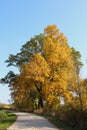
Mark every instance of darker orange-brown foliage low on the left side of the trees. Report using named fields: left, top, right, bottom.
left=10, top=74, right=30, bottom=110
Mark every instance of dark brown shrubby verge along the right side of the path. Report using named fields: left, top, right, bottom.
left=34, top=108, right=87, bottom=130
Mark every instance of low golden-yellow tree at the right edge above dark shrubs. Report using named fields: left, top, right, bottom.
left=72, top=79, right=87, bottom=112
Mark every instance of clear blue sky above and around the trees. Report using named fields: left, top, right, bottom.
left=0, top=0, right=87, bottom=103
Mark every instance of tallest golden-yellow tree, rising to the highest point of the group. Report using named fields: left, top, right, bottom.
left=43, top=25, right=73, bottom=108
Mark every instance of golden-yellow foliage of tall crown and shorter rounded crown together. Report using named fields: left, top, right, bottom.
left=13, top=25, right=73, bottom=109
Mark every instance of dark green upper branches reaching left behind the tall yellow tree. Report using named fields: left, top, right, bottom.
left=5, top=34, right=44, bottom=68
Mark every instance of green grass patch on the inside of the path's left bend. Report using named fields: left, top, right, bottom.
left=0, top=111, right=17, bottom=130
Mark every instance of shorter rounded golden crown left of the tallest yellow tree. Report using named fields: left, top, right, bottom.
left=24, top=54, right=50, bottom=82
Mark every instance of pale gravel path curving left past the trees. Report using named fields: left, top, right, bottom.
left=7, top=112, right=58, bottom=130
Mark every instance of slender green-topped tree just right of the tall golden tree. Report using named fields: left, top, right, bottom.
left=71, top=48, right=83, bottom=111
